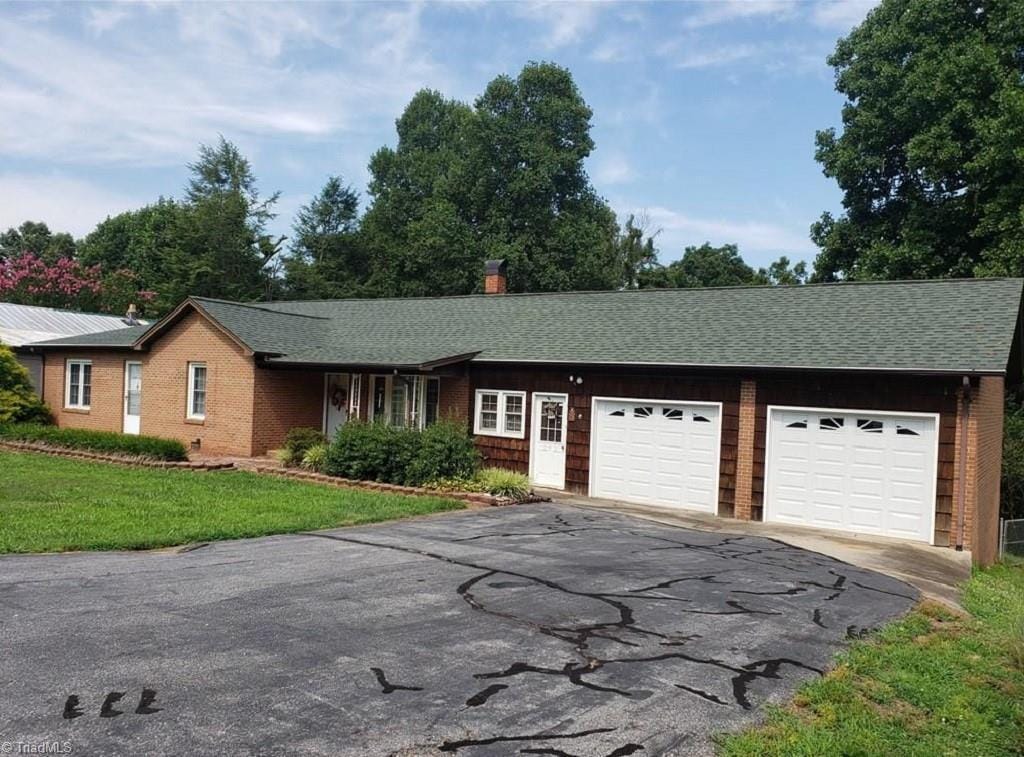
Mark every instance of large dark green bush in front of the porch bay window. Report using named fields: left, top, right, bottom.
left=324, top=421, right=479, bottom=486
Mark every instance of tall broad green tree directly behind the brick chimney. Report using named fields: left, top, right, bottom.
left=361, top=64, right=623, bottom=295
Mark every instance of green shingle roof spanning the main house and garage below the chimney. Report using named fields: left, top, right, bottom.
left=18, top=279, right=1024, bottom=373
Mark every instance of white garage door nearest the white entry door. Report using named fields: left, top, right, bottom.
left=590, top=399, right=722, bottom=512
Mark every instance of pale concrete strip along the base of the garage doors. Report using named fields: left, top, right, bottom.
left=537, top=490, right=971, bottom=609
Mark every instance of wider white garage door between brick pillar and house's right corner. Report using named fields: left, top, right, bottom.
left=765, top=408, right=938, bottom=543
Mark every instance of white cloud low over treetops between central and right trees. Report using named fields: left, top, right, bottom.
left=615, top=203, right=817, bottom=265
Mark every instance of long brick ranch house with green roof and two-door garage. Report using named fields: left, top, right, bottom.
left=18, top=261, right=1024, bottom=562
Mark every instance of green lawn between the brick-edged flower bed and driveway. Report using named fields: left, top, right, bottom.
left=0, top=452, right=463, bottom=553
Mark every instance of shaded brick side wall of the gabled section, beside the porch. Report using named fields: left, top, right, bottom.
left=252, top=368, right=324, bottom=455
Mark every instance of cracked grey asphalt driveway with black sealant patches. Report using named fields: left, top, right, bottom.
left=0, top=505, right=916, bottom=757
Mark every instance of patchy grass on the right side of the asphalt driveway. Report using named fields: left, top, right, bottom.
left=719, top=564, right=1024, bottom=757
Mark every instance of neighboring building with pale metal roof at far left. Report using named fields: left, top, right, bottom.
left=0, top=302, right=145, bottom=391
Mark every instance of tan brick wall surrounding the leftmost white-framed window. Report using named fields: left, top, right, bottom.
left=43, top=351, right=126, bottom=431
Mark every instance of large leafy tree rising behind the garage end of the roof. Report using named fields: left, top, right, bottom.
left=811, top=0, right=1024, bottom=281
